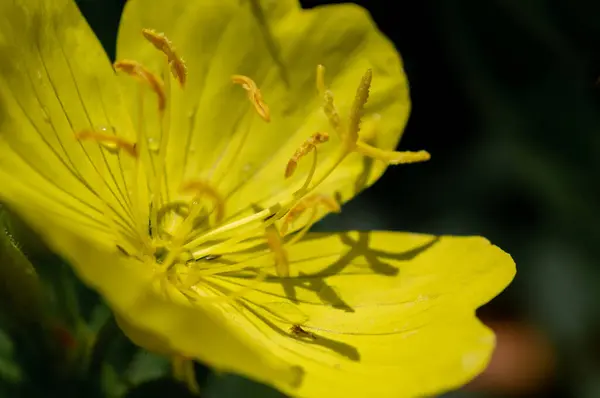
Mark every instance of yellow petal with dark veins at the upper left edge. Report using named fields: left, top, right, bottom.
left=0, top=0, right=140, bottom=247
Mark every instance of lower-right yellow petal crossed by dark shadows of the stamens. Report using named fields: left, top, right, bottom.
left=197, top=232, right=515, bottom=397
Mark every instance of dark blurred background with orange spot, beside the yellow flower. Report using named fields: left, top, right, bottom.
left=0, top=0, right=600, bottom=398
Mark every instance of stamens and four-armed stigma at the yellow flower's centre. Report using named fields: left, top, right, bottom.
left=76, top=29, right=429, bottom=299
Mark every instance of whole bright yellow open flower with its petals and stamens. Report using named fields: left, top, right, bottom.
left=0, top=0, right=514, bottom=398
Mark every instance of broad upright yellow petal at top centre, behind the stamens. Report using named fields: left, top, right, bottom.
left=117, top=0, right=410, bottom=224
